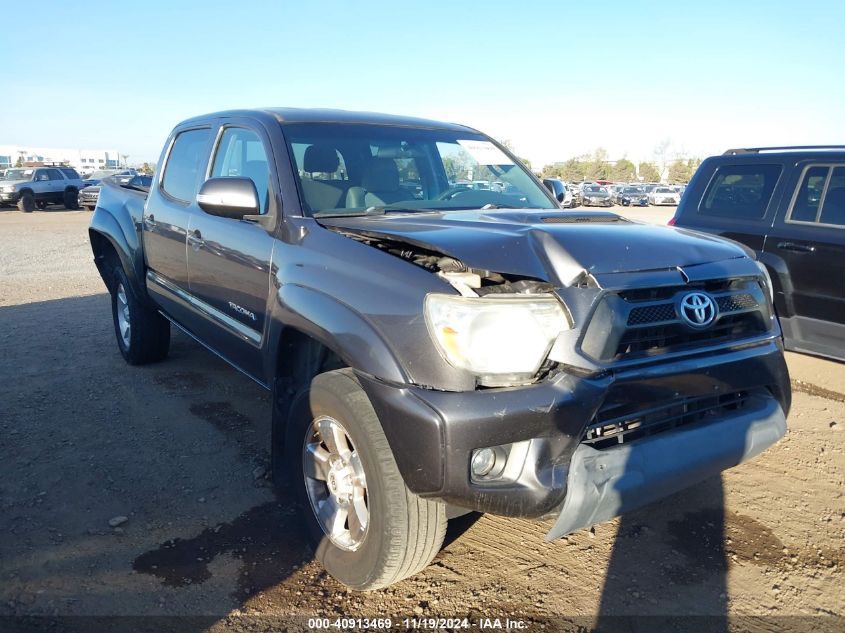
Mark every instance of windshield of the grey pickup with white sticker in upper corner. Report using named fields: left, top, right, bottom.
left=284, top=123, right=557, bottom=217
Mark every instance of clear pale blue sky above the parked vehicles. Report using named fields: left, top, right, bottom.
left=0, top=0, right=845, bottom=167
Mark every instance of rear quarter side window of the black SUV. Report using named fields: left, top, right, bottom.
left=698, top=165, right=781, bottom=220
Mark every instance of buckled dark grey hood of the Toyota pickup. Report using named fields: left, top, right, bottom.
left=319, top=209, right=747, bottom=286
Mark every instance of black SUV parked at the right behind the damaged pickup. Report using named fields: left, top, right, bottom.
left=670, top=145, right=845, bottom=360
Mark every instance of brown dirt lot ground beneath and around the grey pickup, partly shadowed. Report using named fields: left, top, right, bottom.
left=0, top=209, right=845, bottom=630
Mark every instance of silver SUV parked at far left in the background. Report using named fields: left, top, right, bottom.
left=0, top=166, right=84, bottom=213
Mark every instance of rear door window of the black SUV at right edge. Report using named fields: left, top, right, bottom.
left=788, top=165, right=845, bottom=227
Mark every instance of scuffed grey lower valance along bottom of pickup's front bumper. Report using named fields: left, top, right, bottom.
left=546, top=397, right=786, bottom=541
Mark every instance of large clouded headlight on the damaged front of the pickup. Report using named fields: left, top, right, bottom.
left=425, top=294, right=571, bottom=387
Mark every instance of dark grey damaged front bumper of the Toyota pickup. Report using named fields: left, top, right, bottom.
left=359, top=339, right=791, bottom=524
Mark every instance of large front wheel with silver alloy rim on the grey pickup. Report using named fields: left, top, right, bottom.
left=285, top=369, right=446, bottom=591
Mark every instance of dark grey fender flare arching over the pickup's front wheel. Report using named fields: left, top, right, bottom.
left=265, top=284, right=410, bottom=384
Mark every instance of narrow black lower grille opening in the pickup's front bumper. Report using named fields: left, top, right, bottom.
left=581, top=391, right=751, bottom=450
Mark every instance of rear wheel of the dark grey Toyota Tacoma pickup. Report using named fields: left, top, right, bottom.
left=111, top=266, right=170, bottom=365
